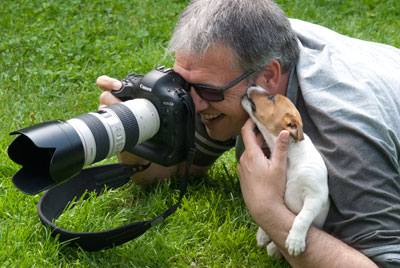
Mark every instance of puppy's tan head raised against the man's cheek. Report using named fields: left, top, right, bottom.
left=242, top=86, right=304, bottom=141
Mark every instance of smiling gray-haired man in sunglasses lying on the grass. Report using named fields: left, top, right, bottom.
left=97, top=0, right=400, bottom=267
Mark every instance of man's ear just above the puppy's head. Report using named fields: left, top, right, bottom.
left=255, top=60, right=281, bottom=94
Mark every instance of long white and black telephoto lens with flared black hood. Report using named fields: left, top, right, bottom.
left=8, top=98, right=160, bottom=194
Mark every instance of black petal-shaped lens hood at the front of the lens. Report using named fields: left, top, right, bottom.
left=8, top=120, right=84, bottom=194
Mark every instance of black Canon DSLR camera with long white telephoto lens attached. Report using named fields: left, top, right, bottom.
left=8, top=66, right=194, bottom=194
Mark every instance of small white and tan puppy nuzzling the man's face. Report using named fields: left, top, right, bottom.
left=242, top=86, right=329, bottom=257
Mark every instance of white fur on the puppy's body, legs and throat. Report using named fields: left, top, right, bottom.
left=242, top=87, right=329, bottom=257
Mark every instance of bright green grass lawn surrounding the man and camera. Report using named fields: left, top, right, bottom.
left=0, top=0, right=400, bottom=267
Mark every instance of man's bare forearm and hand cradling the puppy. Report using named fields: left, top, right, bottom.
left=238, top=120, right=377, bottom=268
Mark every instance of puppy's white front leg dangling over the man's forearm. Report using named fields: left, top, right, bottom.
left=285, top=196, right=323, bottom=256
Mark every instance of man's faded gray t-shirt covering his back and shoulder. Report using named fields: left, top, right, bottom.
left=192, top=19, right=400, bottom=267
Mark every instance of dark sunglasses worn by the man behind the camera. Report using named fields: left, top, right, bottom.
left=189, top=70, right=255, bottom=102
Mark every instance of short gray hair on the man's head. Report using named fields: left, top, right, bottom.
left=169, top=0, right=299, bottom=73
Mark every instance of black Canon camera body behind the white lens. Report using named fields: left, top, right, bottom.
left=113, top=66, right=195, bottom=166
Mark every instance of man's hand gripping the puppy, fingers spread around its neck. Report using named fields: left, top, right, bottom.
left=238, top=119, right=289, bottom=222
